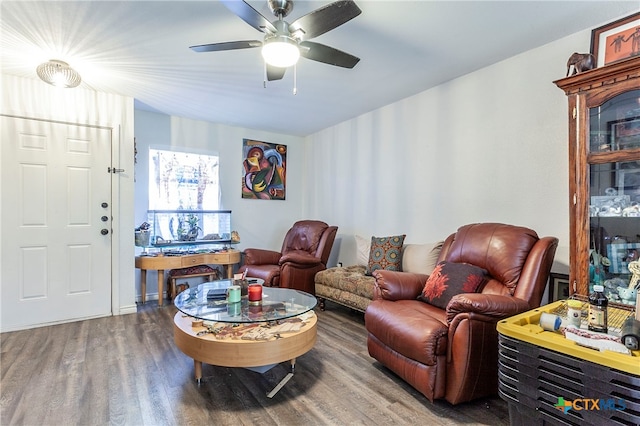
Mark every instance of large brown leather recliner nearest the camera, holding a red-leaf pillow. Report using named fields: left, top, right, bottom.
left=365, top=223, right=558, bottom=404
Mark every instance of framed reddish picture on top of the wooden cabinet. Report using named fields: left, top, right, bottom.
left=591, top=12, right=640, bottom=67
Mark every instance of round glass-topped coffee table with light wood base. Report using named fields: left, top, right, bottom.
left=173, top=280, right=317, bottom=398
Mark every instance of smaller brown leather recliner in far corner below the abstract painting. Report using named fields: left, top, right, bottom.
left=239, top=220, right=338, bottom=295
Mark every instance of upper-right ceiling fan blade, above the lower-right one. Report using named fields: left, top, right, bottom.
left=289, top=0, right=362, bottom=40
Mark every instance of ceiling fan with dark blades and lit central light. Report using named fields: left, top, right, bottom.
left=190, top=0, right=362, bottom=81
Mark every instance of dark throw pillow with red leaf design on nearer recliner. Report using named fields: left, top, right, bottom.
left=418, top=261, right=487, bottom=309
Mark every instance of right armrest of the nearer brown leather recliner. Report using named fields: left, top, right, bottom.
left=446, top=293, right=531, bottom=324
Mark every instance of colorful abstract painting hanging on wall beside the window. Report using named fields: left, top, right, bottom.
left=242, top=139, right=287, bottom=200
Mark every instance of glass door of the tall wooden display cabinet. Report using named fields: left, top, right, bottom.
left=587, top=90, right=640, bottom=305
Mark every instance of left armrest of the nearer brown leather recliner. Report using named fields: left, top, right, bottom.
left=373, top=269, right=429, bottom=300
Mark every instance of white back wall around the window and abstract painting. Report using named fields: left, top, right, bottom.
left=135, top=109, right=305, bottom=299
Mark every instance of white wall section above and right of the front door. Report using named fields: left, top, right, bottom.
left=0, top=75, right=136, bottom=315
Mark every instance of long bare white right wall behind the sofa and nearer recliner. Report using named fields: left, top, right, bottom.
left=304, top=31, right=590, bottom=273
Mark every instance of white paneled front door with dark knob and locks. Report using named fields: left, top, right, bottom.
left=0, top=117, right=112, bottom=331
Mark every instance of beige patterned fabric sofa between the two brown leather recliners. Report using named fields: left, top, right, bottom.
left=315, top=236, right=444, bottom=312
